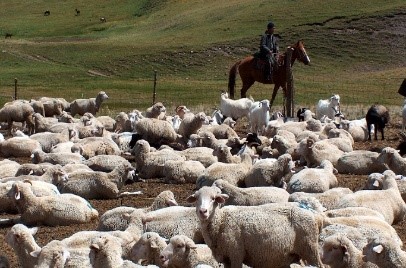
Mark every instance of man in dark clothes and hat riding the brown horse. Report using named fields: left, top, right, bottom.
left=259, top=22, right=279, bottom=80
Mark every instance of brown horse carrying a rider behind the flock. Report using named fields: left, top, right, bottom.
left=228, top=41, right=310, bottom=106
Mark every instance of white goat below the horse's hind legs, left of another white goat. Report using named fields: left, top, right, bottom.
left=220, top=92, right=254, bottom=120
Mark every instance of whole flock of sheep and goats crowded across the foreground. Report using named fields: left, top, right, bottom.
left=0, top=91, right=406, bottom=268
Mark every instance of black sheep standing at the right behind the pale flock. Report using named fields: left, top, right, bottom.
left=365, top=104, right=390, bottom=140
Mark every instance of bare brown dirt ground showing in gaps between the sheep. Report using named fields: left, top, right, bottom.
left=0, top=124, right=406, bottom=267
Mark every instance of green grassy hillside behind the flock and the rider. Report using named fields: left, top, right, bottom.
left=0, top=0, right=406, bottom=115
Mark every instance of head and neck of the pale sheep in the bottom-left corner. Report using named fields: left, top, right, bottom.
left=5, top=224, right=41, bottom=268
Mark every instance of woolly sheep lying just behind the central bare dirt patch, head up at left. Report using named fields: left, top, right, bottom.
left=132, top=140, right=184, bottom=179
